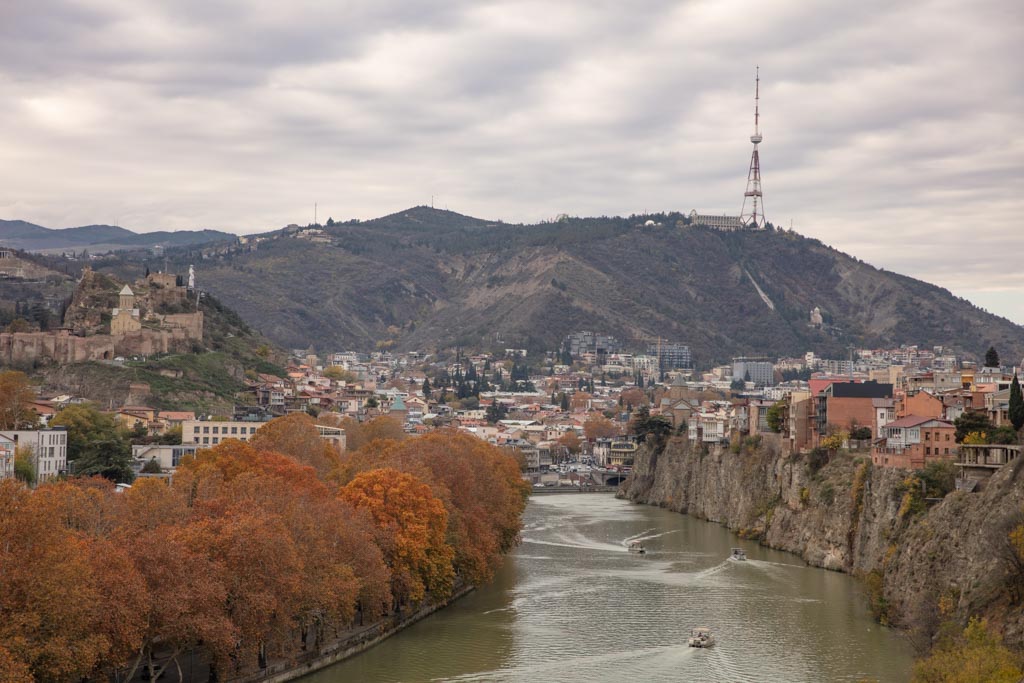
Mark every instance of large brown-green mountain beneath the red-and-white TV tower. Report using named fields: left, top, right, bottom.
left=101, top=207, right=1024, bottom=366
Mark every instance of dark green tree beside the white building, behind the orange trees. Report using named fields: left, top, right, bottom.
left=50, top=404, right=135, bottom=482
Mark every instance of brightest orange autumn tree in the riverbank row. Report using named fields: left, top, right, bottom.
left=340, top=468, right=455, bottom=605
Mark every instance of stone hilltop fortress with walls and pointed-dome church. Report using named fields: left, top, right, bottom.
left=0, top=267, right=203, bottom=367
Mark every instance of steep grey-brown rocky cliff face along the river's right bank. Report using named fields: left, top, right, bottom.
left=620, top=439, right=1024, bottom=646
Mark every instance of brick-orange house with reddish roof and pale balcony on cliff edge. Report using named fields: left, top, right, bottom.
left=871, top=415, right=957, bottom=469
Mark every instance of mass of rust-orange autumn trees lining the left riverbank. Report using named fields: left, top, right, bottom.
left=0, top=416, right=526, bottom=681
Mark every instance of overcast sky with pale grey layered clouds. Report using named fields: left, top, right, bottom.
left=0, top=0, right=1024, bottom=323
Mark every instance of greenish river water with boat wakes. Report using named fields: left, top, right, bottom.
left=302, top=494, right=911, bottom=683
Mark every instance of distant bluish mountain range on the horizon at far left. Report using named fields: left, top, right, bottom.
left=0, top=220, right=234, bottom=253
